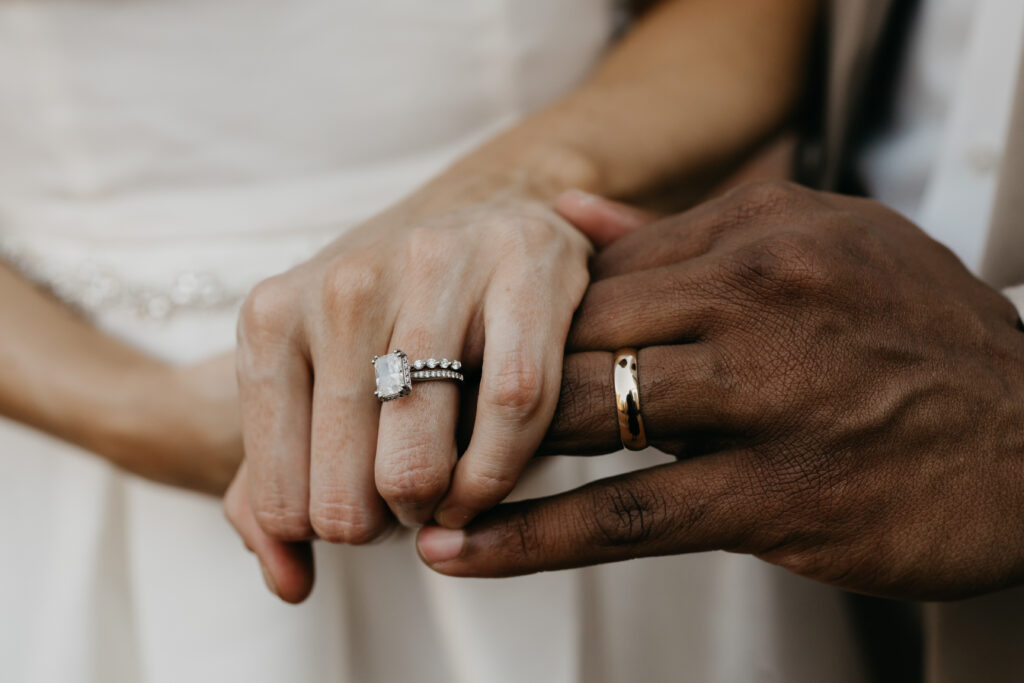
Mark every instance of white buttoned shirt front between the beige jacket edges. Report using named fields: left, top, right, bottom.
left=862, top=0, right=1024, bottom=271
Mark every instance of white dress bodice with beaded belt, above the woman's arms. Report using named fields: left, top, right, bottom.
left=0, top=0, right=613, bottom=331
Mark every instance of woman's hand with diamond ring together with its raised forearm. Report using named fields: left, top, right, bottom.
left=225, top=0, right=816, bottom=601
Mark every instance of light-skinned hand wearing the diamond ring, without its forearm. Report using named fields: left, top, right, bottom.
left=226, top=191, right=591, bottom=561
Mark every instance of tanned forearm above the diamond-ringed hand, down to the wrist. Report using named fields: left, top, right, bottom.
left=399, top=0, right=817, bottom=213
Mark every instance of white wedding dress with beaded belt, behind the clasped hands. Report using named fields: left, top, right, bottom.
left=0, top=0, right=866, bottom=683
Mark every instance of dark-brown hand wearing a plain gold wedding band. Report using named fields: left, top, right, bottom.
left=419, top=183, right=1024, bottom=598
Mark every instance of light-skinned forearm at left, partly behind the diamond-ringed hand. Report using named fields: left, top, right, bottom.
left=0, top=263, right=242, bottom=496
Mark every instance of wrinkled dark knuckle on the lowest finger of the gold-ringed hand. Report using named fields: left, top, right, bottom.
left=585, top=481, right=668, bottom=548
